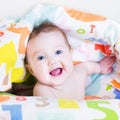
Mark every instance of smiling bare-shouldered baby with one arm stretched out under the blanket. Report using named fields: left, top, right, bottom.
left=26, top=23, right=116, bottom=100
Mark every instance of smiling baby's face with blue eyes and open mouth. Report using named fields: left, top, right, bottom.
left=27, top=31, right=73, bottom=86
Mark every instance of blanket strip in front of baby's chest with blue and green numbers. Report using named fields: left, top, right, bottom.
left=0, top=96, right=120, bottom=120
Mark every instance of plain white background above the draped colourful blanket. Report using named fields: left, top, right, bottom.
left=0, top=0, right=120, bottom=23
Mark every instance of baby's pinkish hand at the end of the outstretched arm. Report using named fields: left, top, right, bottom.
left=99, top=56, right=116, bottom=74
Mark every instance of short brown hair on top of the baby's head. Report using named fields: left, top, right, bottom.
left=29, top=22, right=70, bottom=48
